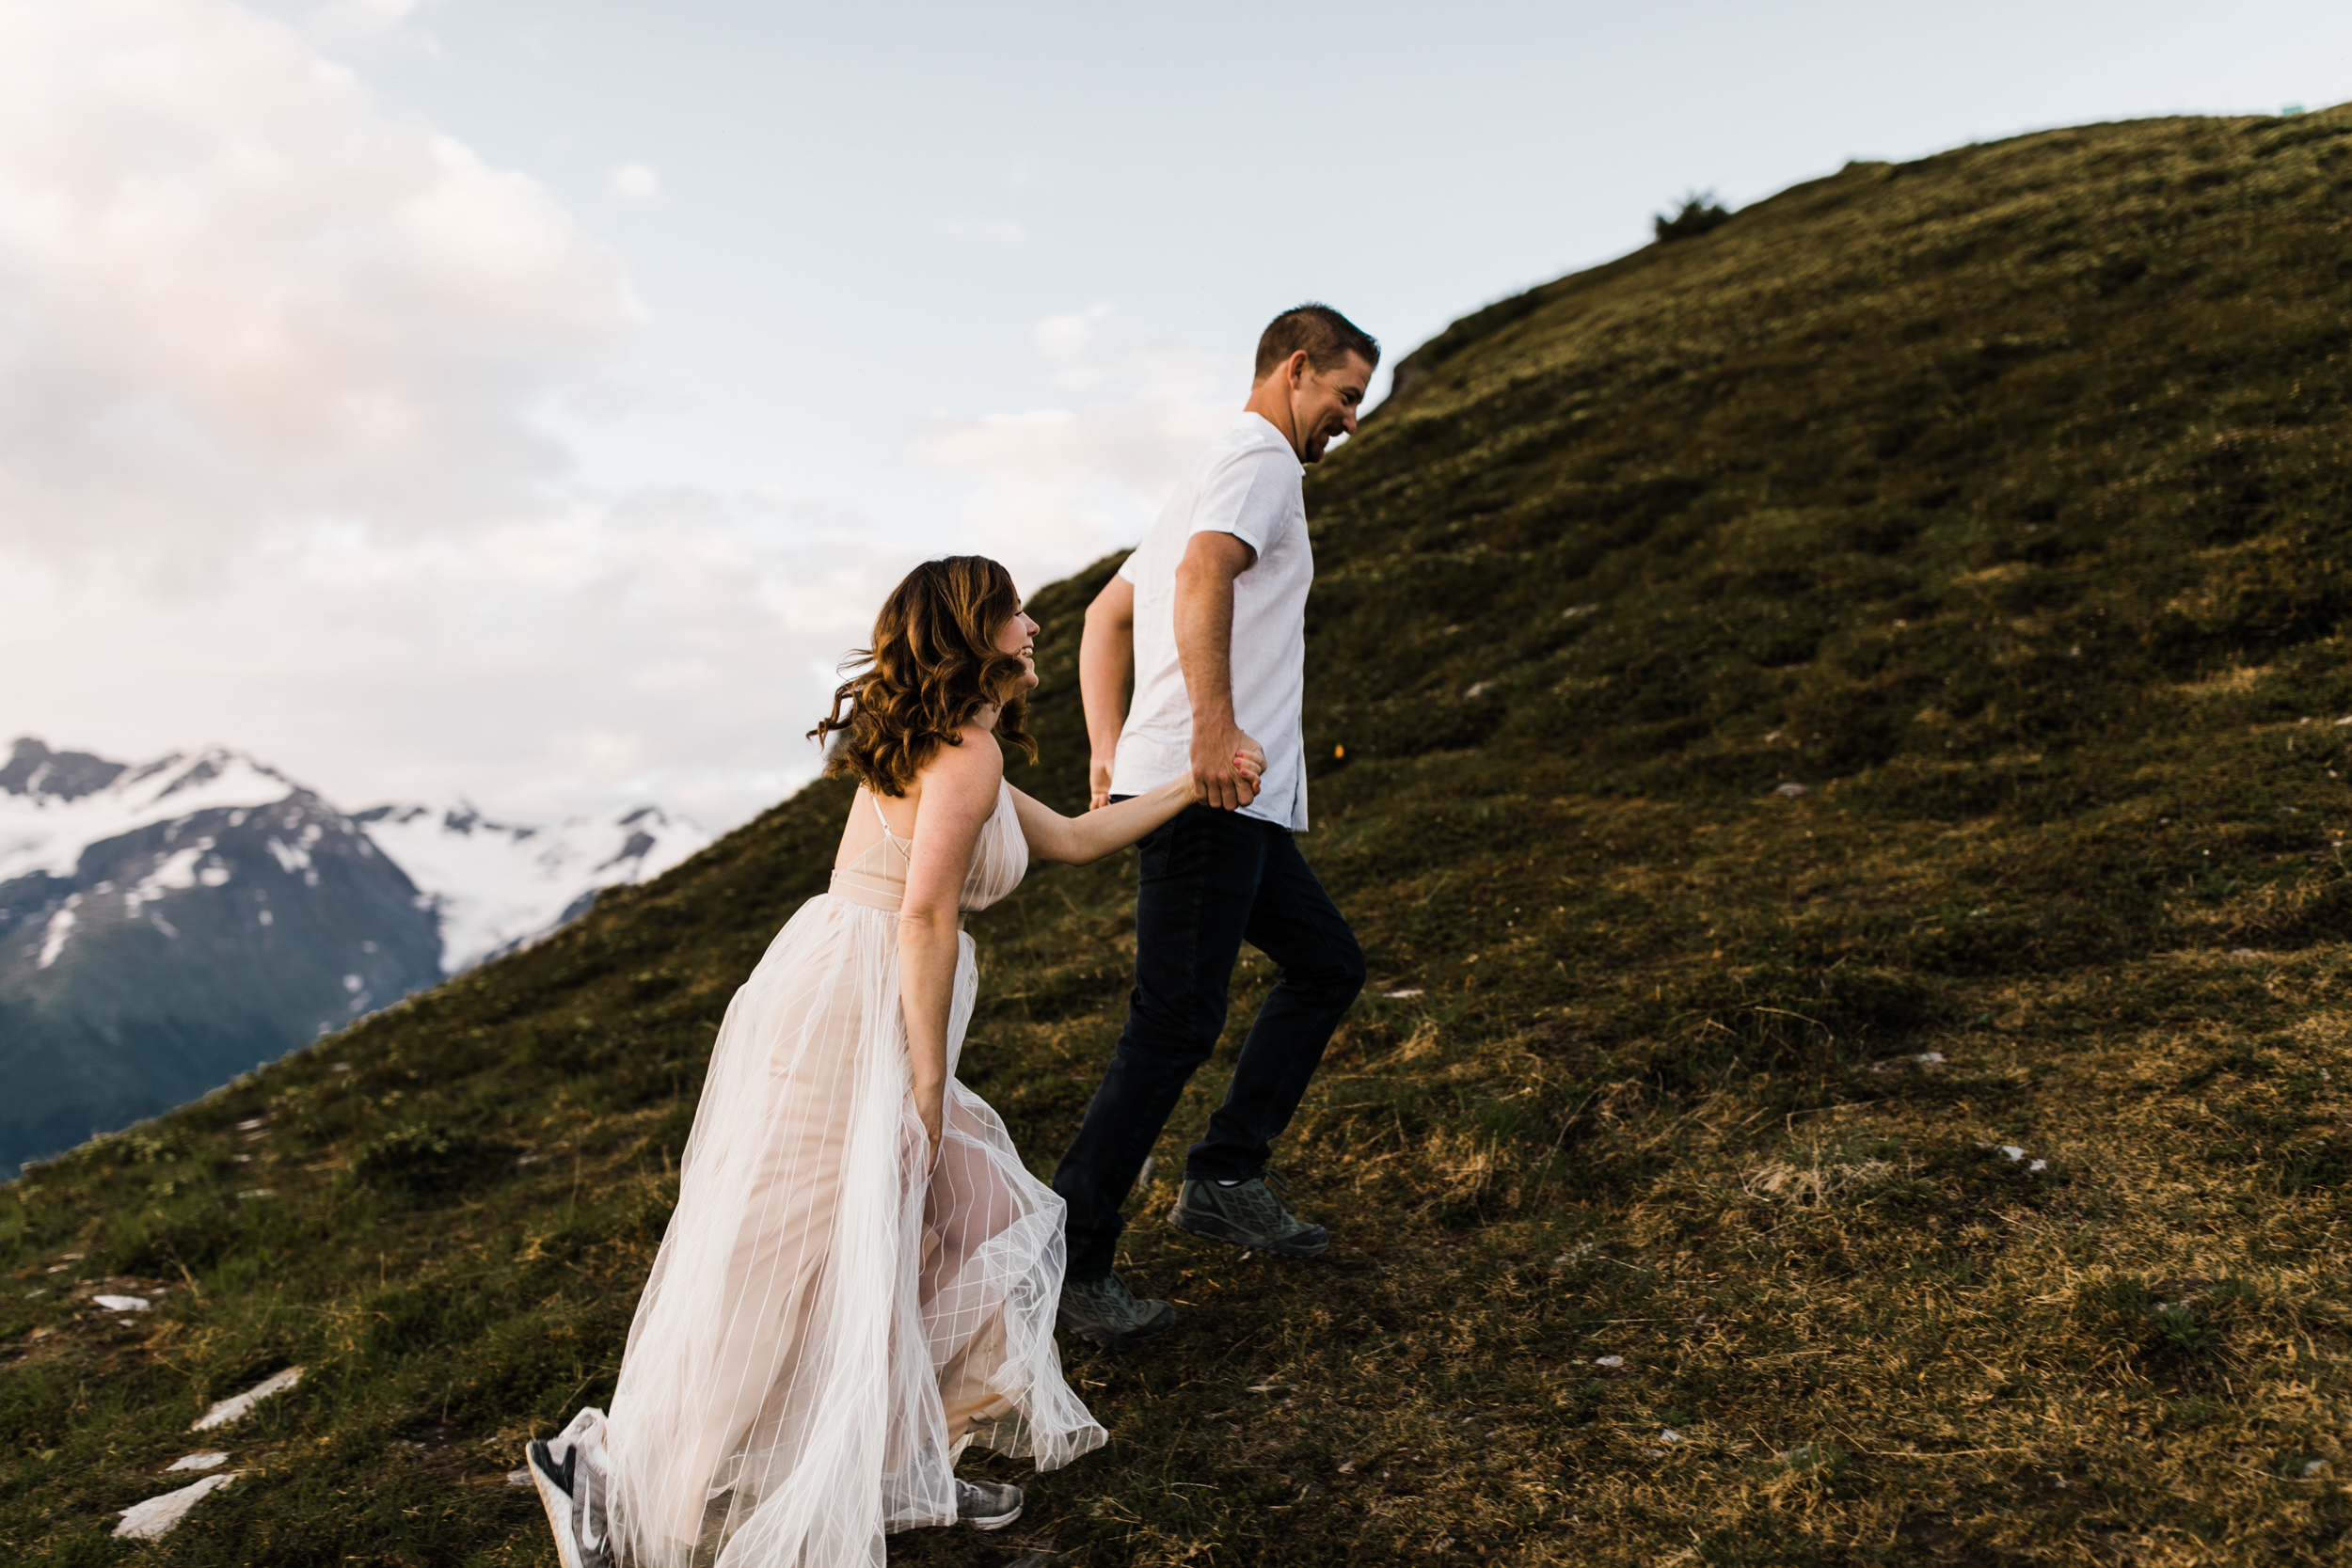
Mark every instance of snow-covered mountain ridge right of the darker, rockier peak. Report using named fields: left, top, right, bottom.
left=358, top=801, right=710, bottom=974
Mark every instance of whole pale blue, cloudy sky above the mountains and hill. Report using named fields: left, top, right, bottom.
left=0, top=0, right=2352, bottom=828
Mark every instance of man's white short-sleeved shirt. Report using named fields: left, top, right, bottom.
left=1110, top=414, right=1315, bottom=832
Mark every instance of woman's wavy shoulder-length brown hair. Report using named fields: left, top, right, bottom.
left=809, top=555, right=1038, bottom=797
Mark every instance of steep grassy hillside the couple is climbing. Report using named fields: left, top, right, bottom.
left=0, top=110, right=2352, bottom=1566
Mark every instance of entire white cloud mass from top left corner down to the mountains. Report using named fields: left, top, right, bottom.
left=0, top=0, right=908, bottom=825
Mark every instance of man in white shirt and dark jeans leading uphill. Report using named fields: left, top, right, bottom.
left=1054, top=306, right=1381, bottom=1347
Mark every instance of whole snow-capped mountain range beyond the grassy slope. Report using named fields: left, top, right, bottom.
left=0, top=738, right=710, bottom=1173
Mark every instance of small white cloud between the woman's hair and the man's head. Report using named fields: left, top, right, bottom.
left=917, top=306, right=1249, bottom=585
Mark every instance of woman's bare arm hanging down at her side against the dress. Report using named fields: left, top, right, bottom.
left=898, top=724, right=1005, bottom=1149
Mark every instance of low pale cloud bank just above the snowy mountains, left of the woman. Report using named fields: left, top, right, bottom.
left=0, top=489, right=913, bottom=825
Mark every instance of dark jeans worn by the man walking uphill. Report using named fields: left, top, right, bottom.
left=1054, top=806, right=1364, bottom=1279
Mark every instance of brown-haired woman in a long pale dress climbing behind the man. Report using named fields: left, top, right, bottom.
left=530, top=555, right=1265, bottom=1568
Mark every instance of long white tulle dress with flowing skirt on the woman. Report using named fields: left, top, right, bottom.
left=605, top=787, right=1104, bottom=1568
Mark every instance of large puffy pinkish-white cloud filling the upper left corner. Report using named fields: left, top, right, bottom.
left=0, top=0, right=643, bottom=566
